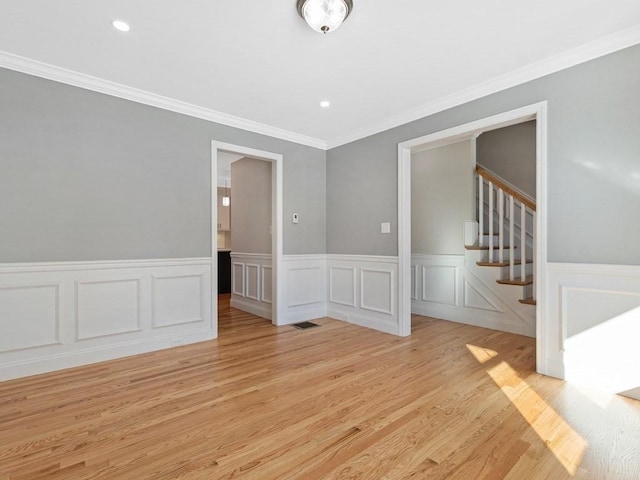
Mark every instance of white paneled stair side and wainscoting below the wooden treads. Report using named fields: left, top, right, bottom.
left=411, top=251, right=536, bottom=337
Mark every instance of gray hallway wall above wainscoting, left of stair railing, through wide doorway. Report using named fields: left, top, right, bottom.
left=411, top=140, right=475, bottom=255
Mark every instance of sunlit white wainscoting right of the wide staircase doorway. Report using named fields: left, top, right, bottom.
left=544, top=263, right=640, bottom=399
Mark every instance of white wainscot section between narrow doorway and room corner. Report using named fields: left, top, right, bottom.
left=278, top=255, right=327, bottom=325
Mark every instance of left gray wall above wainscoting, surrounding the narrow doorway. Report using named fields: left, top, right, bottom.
left=0, top=69, right=326, bottom=262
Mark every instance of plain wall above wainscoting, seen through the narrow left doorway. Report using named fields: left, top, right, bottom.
left=230, top=157, right=271, bottom=254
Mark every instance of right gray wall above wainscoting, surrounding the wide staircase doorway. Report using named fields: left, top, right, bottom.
left=327, top=46, right=640, bottom=265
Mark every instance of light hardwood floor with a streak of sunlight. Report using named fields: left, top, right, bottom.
left=0, top=298, right=640, bottom=480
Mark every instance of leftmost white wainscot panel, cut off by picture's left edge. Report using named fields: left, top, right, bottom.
left=0, top=283, right=61, bottom=353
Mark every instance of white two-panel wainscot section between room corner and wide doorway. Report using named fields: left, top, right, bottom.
left=327, top=255, right=399, bottom=334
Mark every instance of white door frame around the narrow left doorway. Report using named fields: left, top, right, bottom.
left=211, top=140, right=284, bottom=337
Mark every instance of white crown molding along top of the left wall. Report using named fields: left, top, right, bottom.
left=0, top=51, right=327, bottom=150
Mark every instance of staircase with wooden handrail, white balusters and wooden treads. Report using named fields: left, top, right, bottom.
left=465, top=165, right=536, bottom=306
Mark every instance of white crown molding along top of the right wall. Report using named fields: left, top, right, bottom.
left=327, top=25, right=640, bottom=149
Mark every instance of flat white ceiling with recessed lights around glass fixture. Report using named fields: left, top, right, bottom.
left=0, top=0, right=640, bottom=145
